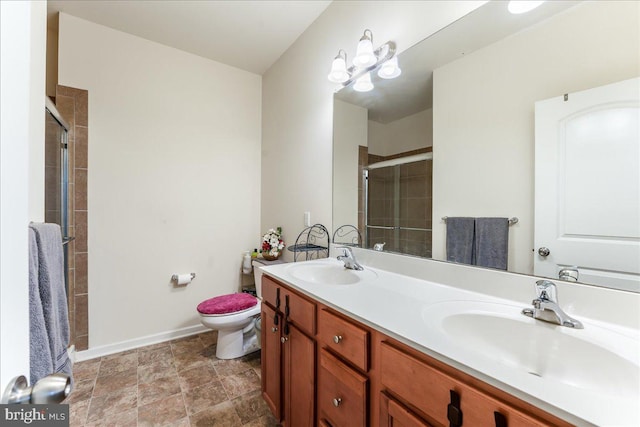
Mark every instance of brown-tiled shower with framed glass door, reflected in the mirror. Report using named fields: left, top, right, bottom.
left=362, top=152, right=433, bottom=258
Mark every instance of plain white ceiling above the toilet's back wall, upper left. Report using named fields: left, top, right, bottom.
left=47, top=0, right=331, bottom=74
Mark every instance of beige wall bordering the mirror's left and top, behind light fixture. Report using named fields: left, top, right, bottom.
left=261, top=1, right=483, bottom=254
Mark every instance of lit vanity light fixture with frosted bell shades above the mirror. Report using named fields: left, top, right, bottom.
left=327, top=30, right=402, bottom=92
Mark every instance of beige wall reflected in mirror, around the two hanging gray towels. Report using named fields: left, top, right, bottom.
left=433, top=1, right=640, bottom=274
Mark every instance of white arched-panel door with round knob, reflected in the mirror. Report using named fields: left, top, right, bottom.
left=534, top=78, right=640, bottom=291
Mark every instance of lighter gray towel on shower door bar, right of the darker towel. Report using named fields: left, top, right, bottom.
left=30, top=223, right=72, bottom=384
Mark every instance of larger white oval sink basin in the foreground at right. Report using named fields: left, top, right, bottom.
left=422, top=301, right=640, bottom=397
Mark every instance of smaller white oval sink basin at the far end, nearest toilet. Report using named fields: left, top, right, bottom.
left=287, top=262, right=378, bottom=285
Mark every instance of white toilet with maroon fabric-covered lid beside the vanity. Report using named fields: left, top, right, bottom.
left=197, top=259, right=282, bottom=359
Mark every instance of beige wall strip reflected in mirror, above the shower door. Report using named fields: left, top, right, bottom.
left=369, top=108, right=433, bottom=156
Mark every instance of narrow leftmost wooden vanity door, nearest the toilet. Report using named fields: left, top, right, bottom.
left=261, top=304, right=282, bottom=421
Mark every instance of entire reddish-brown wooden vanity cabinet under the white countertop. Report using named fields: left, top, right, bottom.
left=262, top=276, right=570, bottom=427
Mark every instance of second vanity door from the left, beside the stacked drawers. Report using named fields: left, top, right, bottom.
left=282, top=325, right=316, bottom=427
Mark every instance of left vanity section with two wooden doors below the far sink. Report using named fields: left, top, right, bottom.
left=261, top=276, right=316, bottom=427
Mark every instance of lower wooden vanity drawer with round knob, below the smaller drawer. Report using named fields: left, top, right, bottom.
left=318, top=349, right=367, bottom=427
